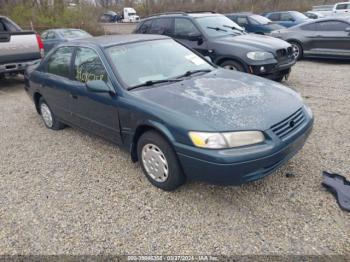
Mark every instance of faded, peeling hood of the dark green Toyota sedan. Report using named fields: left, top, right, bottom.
left=133, top=69, right=303, bottom=131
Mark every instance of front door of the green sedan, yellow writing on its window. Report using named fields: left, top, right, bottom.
left=70, top=47, right=121, bottom=143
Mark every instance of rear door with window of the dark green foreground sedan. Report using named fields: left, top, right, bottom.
left=40, top=47, right=74, bottom=122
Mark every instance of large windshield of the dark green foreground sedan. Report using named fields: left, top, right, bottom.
left=107, top=39, right=214, bottom=87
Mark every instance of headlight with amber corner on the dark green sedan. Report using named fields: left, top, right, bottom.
left=189, top=131, right=265, bottom=149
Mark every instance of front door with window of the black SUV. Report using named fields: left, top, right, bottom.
left=174, top=18, right=208, bottom=56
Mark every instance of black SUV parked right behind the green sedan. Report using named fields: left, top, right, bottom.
left=135, top=12, right=295, bottom=81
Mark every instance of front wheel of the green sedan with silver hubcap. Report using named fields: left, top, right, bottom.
left=137, top=131, right=186, bottom=191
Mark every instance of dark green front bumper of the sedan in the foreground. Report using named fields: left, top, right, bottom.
left=177, top=113, right=314, bottom=186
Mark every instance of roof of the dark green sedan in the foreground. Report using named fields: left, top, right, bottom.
left=69, top=34, right=170, bottom=48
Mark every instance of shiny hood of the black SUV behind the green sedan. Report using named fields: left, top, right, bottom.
left=217, top=34, right=290, bottom=52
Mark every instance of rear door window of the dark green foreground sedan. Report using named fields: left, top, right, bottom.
left=47, top=46, right=74, bottom=78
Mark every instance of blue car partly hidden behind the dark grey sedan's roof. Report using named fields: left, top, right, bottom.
left=263, top=11, right=309, bottom=27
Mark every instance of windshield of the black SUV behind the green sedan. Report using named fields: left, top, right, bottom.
left=197, top=15, right=244, bottom=37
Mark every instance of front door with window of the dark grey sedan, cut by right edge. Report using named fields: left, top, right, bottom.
left=313, top=20, right=350, bottom=56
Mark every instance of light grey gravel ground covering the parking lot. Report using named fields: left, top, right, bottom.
left=0, top=61, right=350, bottom=255
